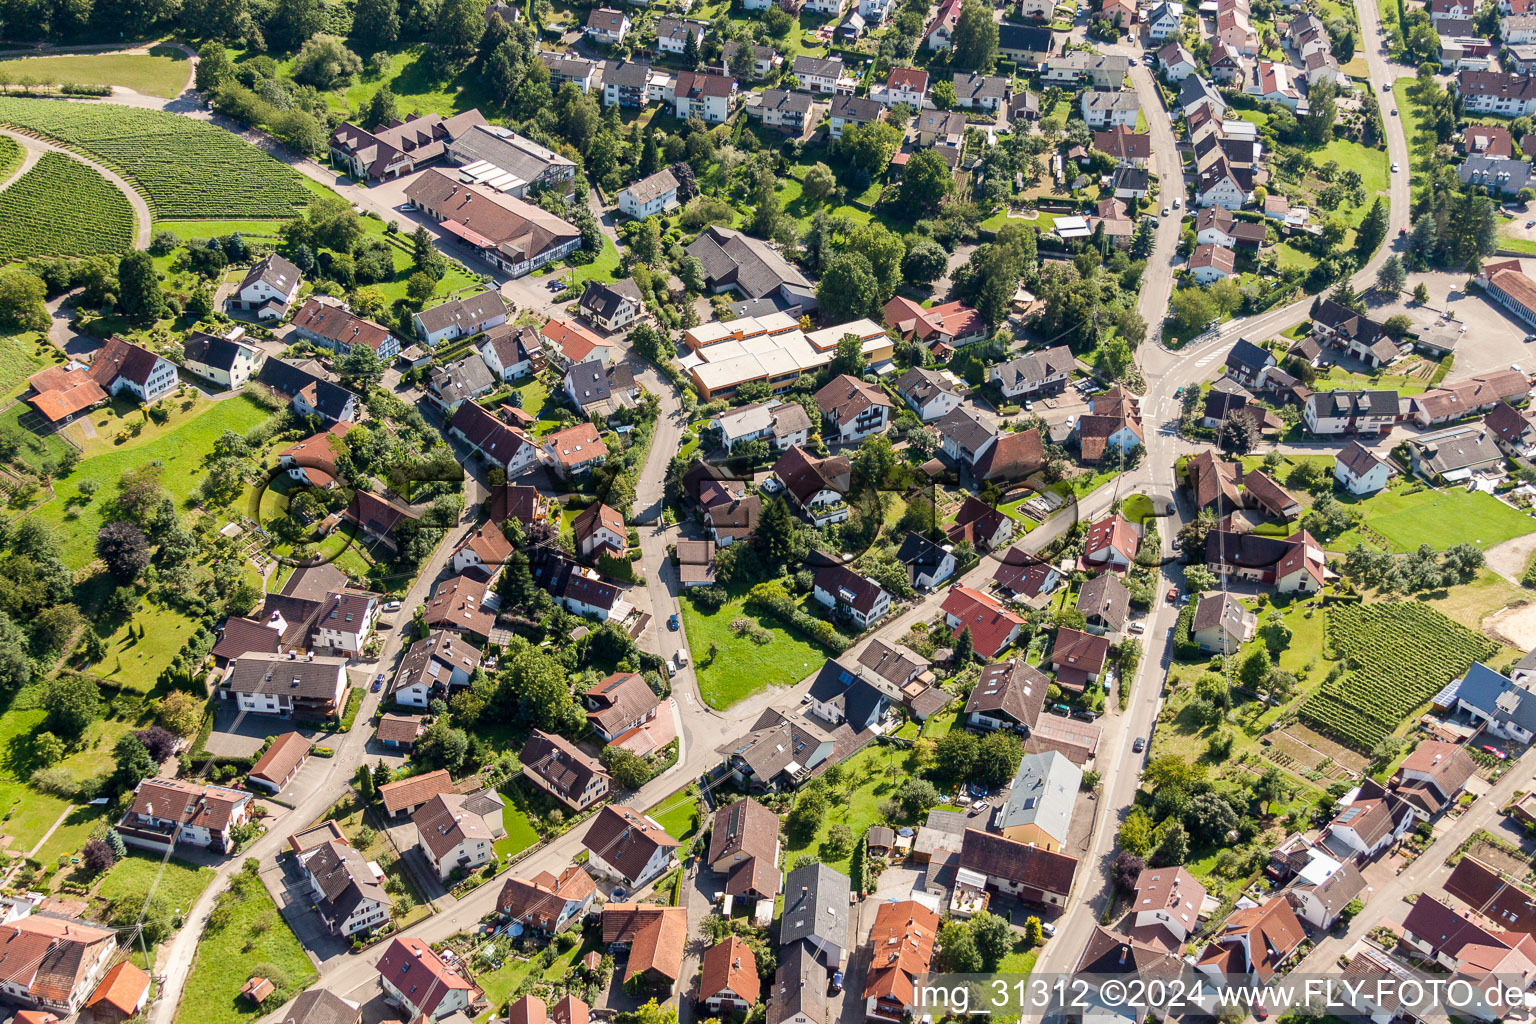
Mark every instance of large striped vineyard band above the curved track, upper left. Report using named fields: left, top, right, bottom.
left=0, top=97, right=315, bottom=220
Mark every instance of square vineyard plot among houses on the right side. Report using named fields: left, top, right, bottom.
left=1301, top=602, right=1499, bottom=752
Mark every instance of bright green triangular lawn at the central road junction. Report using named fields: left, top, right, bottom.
left=682, top=596, right=826, bottom=711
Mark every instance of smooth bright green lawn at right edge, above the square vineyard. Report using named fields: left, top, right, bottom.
left=1329, top=482, right=1536, bottom=551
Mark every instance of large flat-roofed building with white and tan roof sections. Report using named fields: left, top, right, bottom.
left=682, top=313, right=892, bottom=401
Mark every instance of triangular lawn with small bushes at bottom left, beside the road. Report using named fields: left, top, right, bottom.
left=175, top=872, right=319, bottom=1024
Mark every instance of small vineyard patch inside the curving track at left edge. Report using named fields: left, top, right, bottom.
left=0, top=154, right=134, bottom=263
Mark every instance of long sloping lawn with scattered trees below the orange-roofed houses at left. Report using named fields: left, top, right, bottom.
left=34, top=396, right=272, bottom=568
